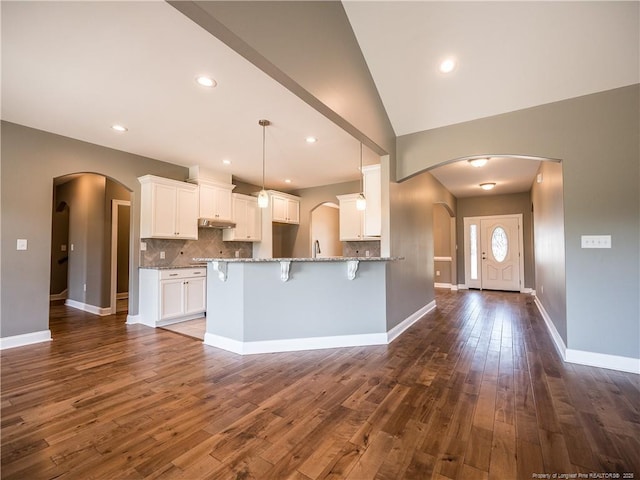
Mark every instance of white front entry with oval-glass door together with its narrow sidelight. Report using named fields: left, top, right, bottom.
left=464, top=215, right=523, bottom=291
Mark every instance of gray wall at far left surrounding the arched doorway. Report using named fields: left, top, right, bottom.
left=0, top=122, right=189, bottom=337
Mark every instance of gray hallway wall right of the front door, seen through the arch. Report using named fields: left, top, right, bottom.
left=531, top=162, right=567, bottom=345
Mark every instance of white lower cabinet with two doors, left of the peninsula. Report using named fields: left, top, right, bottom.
left=140, top=267, right=207, bottom=327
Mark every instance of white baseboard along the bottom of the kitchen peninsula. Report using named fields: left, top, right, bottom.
left=204, top=333, right=387, bottom=355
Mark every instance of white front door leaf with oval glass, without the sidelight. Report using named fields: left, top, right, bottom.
left=480, top=216, right=520, bottom=291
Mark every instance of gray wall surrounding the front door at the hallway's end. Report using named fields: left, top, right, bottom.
left=456, top=192, right=535, bottom=288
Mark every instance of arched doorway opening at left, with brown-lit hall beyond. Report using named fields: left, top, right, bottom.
left=50, top=173, right=131, bottom=315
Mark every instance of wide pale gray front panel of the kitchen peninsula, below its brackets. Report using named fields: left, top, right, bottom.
left=241, top=261, right=386, bottom=342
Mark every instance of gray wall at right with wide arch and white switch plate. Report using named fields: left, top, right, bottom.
left=397, top=85, right=640, bottom=358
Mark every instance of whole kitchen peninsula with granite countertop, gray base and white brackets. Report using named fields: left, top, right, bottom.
left=194, top=257, right=401, bottom=354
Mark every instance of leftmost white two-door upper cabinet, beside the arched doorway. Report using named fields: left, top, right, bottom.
left=138, top=175, right=198, bottom=240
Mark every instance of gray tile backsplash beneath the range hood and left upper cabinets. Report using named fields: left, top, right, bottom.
left=140, top=228, right=253, bottom=267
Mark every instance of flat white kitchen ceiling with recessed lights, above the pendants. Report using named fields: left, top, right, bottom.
left=2, top=1, right=379, bottom=189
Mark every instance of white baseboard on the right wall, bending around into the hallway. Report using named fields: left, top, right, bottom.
left=535, top=297, right=640, bottom=375
